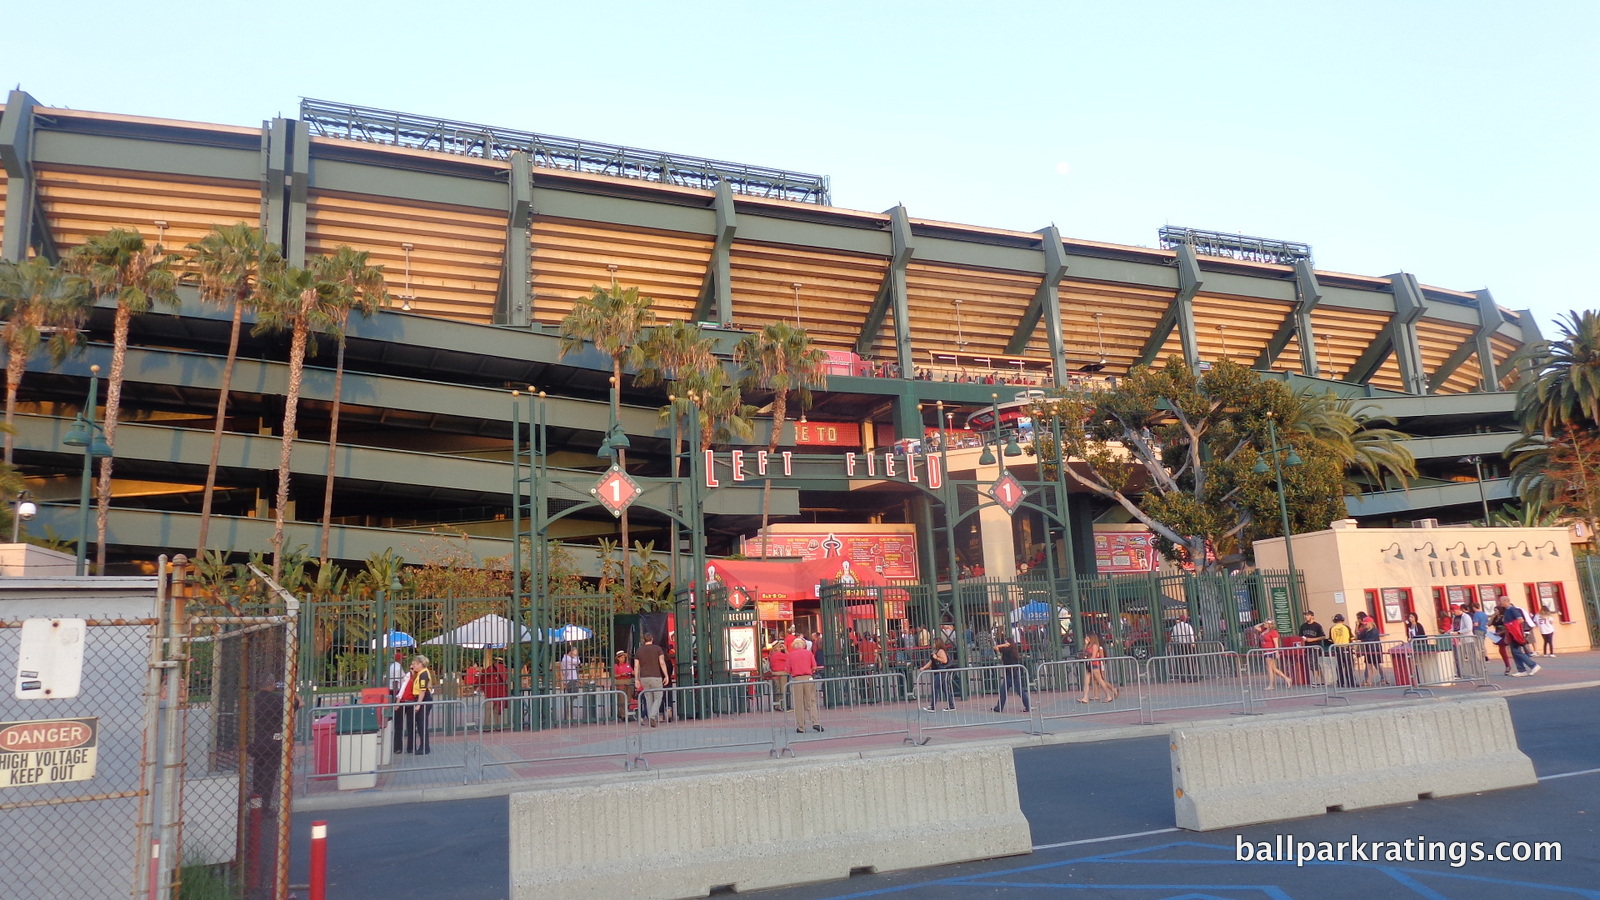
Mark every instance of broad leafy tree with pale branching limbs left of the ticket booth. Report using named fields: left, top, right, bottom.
left=1034, top=359, right=1344, bottom=567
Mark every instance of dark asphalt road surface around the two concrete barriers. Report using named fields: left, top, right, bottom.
left=293, top=687, right=1600, bottom=900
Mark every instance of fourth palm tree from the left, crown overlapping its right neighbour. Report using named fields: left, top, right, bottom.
left=254, top=263, right=344, bottom=580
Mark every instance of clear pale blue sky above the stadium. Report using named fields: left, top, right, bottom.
left=0, top=0, right=1600, bottom=338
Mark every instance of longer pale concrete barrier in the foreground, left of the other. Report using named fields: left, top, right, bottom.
left=510, top=748, right=1032, bottom=900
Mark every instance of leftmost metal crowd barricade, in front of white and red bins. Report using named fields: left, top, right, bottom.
left=304, top=700, right=477, bottom=793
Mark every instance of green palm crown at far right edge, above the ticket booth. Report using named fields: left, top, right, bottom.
left=1517, top=311, right=1600, bottom=434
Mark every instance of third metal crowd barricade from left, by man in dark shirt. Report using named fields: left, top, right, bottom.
left=632, top=681, right=794, bottom=765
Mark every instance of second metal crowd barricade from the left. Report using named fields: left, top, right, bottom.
left=474, top=690, right=637, bottom=780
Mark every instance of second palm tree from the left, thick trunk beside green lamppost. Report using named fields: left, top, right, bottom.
left=66, top=227, right=181, bottom=573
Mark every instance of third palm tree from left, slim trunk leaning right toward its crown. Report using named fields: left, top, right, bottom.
left=189, top=223, right=283, bottom=557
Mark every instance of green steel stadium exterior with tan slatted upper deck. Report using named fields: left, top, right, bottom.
left=0, top=91, right=1538, bottom=570
